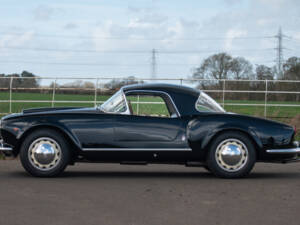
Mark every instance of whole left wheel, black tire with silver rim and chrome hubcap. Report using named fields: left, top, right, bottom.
left=20, top=129, right=70, bottom=177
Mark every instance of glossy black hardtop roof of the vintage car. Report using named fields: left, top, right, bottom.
left=122, top=83, right=200, bottom=116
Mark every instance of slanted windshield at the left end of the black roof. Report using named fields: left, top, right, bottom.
left=100, top=90, right=129, bottom=114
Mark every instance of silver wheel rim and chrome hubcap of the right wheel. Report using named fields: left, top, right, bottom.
left=215, top=139, right=248, bottom=172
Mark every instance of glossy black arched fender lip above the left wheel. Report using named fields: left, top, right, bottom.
left=15, top=124, right=81, bottom=154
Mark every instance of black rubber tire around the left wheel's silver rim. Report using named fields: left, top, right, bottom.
left=20, top=129, right=71, bottom=177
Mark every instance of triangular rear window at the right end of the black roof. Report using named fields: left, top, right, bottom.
left=196, top=91, right=225, bottom=112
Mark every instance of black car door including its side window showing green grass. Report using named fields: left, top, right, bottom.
left=114, top=91, right=188, bottom=150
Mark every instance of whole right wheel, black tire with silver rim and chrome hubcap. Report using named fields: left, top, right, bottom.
left=207, top=132, right=256, bottom=178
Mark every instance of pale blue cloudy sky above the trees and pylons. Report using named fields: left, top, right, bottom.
left=0, top=0, right=300, bottom=81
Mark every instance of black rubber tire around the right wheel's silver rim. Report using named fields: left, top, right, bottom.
left=207, top=131, right=256, bottom=178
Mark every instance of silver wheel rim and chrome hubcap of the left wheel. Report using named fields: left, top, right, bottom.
left=28, top=137, right=62, bottom=170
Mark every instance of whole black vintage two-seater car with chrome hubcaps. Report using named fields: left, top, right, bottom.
left=0, top=84, right=300, bottom=178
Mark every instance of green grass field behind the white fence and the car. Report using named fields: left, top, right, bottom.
left=0, top=92, right=300, bottom=138
